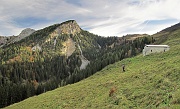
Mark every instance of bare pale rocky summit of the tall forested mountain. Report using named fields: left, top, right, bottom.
left=56, top=20, right=81, bottom=35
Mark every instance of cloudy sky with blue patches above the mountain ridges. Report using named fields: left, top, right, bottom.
left=0, top=0, right=180, bottom=37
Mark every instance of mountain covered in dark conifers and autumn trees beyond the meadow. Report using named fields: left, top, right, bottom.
left=0, top=20, right=155, bottom=107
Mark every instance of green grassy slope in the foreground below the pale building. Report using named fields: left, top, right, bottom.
left=6, top=32, right=180, bottom=109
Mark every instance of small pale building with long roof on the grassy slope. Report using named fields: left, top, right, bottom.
left=143, top=45, right=170, bottom=56
